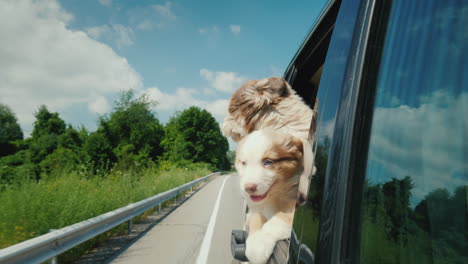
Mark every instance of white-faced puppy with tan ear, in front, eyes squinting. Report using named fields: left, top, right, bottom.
left=235, top=129, right=303, bottom=263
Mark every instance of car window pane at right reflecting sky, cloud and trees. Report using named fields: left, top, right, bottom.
left=360, top=0, right=468, bottom=264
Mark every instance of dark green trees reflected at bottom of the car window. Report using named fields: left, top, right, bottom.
left=361, top=176, right=468, bottom=264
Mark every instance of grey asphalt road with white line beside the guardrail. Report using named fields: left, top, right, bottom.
left=111, top=174, right=245, bottom=264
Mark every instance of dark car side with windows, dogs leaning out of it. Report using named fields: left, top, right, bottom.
left=284, top=0, right=468, bottom=264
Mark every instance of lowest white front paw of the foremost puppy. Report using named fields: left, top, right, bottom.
left=245, top=231, right=276, bottom=264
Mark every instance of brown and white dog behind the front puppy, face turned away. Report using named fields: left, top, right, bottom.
left=221, top=77, right=318, bottom=204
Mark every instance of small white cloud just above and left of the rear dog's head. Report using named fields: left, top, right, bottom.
left=200, top=68, right=247, bottom=93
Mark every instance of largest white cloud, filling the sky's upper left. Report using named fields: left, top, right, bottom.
left=0, top=0, right=142, bottom=132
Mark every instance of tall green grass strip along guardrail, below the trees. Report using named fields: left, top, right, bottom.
left=0, top=164, right=211, bottom=262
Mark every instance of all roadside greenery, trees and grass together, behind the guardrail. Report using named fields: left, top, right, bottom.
left=0, top=90, right=229, bottom=262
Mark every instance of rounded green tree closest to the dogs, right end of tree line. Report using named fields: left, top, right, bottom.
left=163, top=106, right=230, bottom=170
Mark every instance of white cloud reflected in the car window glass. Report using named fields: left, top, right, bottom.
left=369, top=91, right=468, bottom=200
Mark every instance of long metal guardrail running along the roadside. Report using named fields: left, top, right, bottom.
left=0, top=172, right=221, bottom=263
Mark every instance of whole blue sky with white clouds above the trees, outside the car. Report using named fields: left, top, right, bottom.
left=0, top=0, right=326, bottom=141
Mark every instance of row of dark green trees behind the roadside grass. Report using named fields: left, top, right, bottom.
left=0, top=90, right=230, bottom=184
